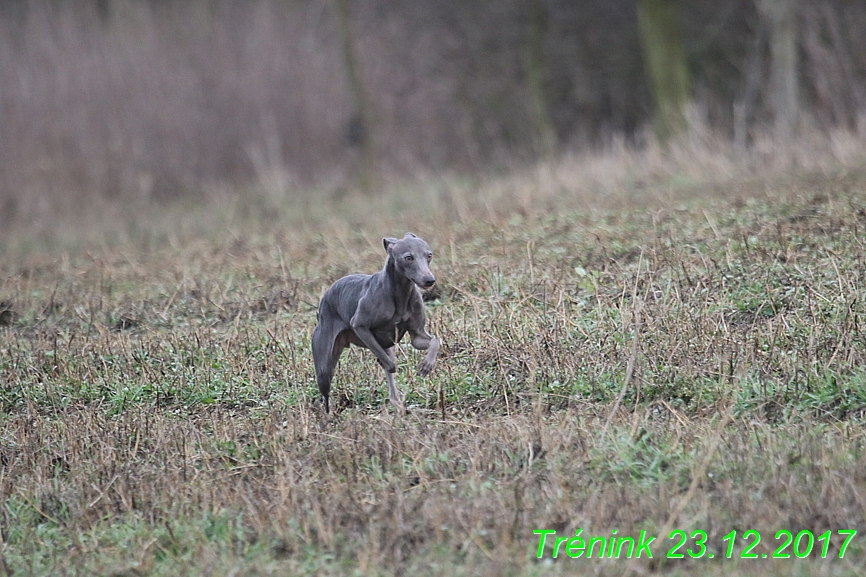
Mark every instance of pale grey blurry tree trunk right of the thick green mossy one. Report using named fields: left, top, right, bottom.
left=758, top=0, right=800, bottom=139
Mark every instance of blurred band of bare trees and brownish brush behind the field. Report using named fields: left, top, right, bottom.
left=0, top=0, right=866, bottom=214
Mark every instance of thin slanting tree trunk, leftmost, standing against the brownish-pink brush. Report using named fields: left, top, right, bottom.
left=333, top=0, right=378, bottom=191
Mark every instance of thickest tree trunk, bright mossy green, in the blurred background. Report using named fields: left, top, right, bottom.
left=637, top=0, right=690, bottom=142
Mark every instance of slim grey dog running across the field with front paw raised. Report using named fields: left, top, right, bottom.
left=312, top=232, right=439, bottom=413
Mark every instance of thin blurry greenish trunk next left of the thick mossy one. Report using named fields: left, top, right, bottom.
left=526, top=0, right=556, bottom=157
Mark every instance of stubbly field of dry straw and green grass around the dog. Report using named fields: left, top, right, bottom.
left=0, top=163, right=866, bottom=577
